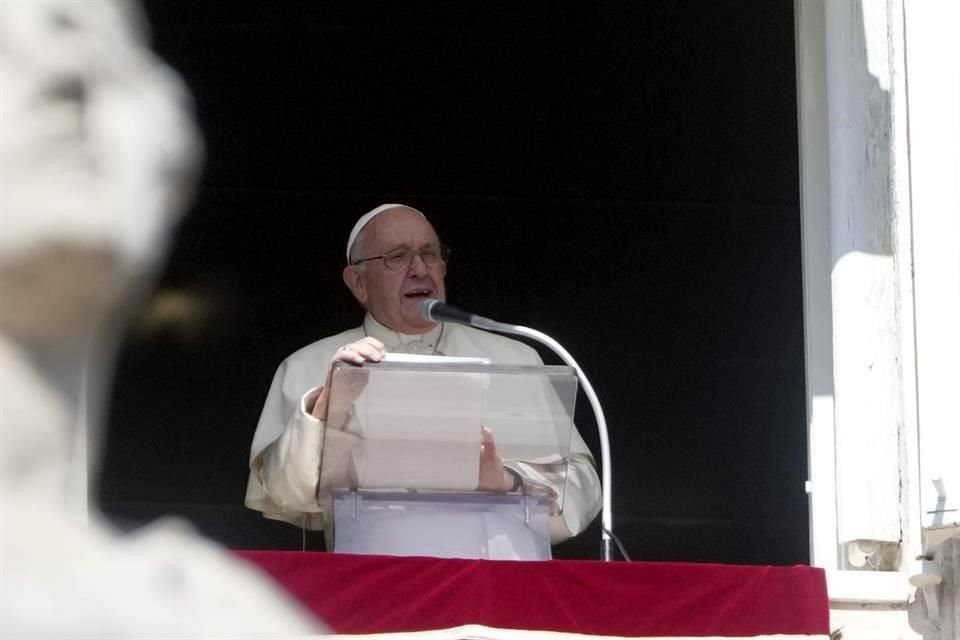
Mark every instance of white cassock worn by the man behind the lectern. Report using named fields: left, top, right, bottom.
left=244, top=314, right=601, bottom=557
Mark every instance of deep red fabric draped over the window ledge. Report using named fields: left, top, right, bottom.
left=237, top=551, right=829, bottom=636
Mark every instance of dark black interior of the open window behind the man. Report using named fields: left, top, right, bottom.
left=99, top=0, right=808, bottom=564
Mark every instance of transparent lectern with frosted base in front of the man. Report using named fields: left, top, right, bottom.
left=318, top=356, right=577, bottom=560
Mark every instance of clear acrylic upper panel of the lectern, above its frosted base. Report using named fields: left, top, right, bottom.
left=325, top=359, right=577, bottom=509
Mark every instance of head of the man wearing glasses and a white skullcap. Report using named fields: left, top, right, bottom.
left=343, top=208, right=447, bottom=334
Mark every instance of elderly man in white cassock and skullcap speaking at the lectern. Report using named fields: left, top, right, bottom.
left=245, top=204, right=600, bottom=543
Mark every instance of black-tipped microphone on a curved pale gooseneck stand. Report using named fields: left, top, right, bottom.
left=465, top=314, right=613, bottom=562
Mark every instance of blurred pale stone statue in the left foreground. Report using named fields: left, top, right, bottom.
left=0, top=0, right=321, bottom=638
